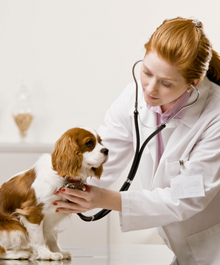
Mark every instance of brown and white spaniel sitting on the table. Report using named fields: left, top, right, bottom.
left=0, top=128, right=108, bottom=260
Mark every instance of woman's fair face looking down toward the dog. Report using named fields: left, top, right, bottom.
left=140, top=51, right=189, bottom=112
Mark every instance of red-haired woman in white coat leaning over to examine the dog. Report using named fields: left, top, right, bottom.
left=56, top=18, right=220, bottom=265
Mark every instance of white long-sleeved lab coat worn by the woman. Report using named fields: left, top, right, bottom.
left=90, top=77, right=220, bottom=265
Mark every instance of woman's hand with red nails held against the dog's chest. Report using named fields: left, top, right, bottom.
left=53, top=186, right=121, bottom=213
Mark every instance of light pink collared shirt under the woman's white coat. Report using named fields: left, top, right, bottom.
left=147, top=89, right=192, bottom=163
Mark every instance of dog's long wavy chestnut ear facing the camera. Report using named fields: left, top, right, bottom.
left=52, top=134, right=83, bottom=177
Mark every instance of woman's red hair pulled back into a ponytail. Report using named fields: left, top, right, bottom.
left=145, top=17, right=220, bottom=85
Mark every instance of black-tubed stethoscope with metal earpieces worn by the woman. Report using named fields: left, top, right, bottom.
left=78, top=60, right=199, bottom=222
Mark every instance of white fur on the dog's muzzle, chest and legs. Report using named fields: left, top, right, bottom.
left=0, top=128, right=107, bottom=260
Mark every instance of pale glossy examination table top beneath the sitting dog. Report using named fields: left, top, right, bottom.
left=0, top=245, right=174, bottom=265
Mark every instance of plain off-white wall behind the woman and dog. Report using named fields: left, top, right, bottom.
left=0, top=0, right=220, bottom=243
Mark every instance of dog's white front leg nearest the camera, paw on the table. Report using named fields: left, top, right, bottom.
left=20, top=216, right=63, bottom=260
